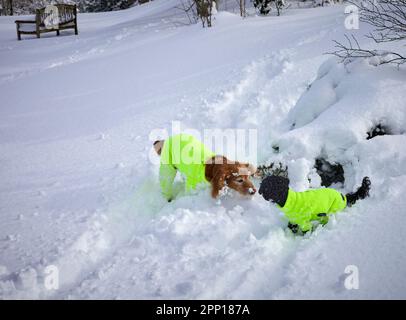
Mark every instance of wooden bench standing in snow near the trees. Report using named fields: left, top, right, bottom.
left=15, top=4, right=78, bottom=40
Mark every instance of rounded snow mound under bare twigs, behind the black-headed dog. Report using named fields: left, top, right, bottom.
left=274, top=59, right=406, bottom=188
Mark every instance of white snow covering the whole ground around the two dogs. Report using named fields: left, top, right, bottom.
left=0, top=0, right=406, bottom=299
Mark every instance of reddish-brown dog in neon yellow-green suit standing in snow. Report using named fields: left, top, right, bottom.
left=153, top=134, right=256, bottom=201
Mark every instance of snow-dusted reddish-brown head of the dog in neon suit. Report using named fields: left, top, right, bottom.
left=206, top=156, right=257, bottom=198
